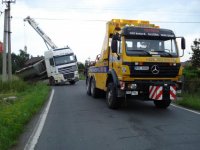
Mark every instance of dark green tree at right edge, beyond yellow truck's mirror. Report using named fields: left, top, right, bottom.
left=191, top=39, right=200, bottom=68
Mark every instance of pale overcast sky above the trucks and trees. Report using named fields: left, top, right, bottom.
left=0, top=0, right=200, bottom=62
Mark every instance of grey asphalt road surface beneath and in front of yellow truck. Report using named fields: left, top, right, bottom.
left=35, top=81, right=200, bottom=150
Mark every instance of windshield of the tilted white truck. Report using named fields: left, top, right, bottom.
left=54, top=54, right=76, bottom=66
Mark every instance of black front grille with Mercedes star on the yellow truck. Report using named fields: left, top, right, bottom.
left=123, top=63, right=180, bottom=78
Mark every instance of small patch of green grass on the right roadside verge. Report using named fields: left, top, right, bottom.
left=176, top=94, right=200, bottom=111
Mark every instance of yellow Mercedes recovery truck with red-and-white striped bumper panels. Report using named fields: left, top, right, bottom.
left=86, top=19, right=185, bottom=109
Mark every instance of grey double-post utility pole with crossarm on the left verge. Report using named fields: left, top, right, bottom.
left=2, top=0, right=16, bottom=81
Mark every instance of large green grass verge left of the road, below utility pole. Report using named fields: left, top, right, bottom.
left=0, top=81, right=50, bottom=150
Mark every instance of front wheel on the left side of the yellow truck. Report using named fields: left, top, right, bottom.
left=106, top=83, right=121, bottom=109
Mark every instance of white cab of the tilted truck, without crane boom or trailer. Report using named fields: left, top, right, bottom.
left=44, top=47, right=79, bottom=85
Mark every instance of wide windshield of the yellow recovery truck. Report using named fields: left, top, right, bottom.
left=125, top=39, right=178, bottom=57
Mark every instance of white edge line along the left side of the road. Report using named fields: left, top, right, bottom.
left=24, top=89, right=54, bottom=150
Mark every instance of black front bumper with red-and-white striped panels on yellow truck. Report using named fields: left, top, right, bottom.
left=118, top=80, right=181, bottom=100
